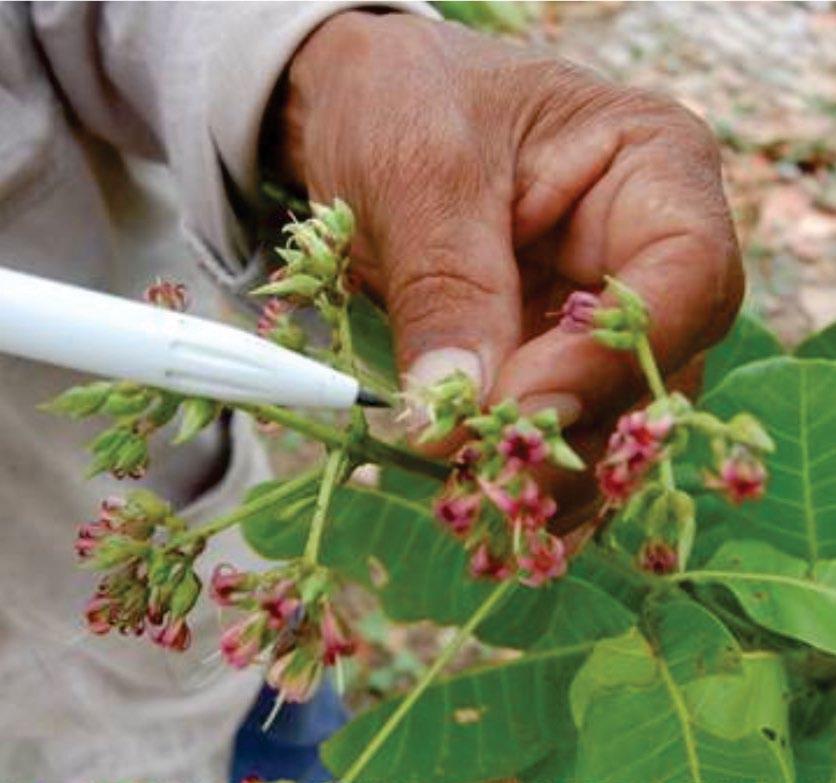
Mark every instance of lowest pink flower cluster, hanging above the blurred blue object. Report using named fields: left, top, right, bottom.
left=209, top=564, right=355, bottom=702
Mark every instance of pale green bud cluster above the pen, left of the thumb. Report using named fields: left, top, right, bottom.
left=252, top=199, right=354, bottom=351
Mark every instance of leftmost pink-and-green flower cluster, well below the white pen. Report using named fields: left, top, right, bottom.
left=75, top=491, right=204, bottom=650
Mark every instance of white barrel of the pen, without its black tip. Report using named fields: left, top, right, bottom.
left=0, top=269, right=359, bottom=408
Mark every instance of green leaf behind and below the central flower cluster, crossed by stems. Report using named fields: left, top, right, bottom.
left=238, top=485, right=632, bottom=648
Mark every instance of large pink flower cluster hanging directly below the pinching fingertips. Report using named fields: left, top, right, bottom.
left=435, top=402, right=583, bottom=587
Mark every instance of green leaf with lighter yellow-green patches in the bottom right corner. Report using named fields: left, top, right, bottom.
left=570, top=600, right=795, bottom=783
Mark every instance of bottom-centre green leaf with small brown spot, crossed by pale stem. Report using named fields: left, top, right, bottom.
left=323, top=579, right=631, bottom=783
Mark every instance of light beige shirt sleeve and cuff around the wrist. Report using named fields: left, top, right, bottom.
left=32, top=2, right=434, bottom=290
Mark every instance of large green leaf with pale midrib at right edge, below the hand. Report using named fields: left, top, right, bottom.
left=702, top=357, right=836, bottom=564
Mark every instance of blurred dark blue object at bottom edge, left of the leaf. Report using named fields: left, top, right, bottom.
left=229, top=681, right=348, bottom=783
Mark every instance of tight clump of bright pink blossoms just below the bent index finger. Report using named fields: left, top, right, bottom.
left=596, top=411, right=673, bottom=504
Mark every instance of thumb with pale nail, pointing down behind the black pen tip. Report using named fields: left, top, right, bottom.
left=380, top=199, right=521, bottom=398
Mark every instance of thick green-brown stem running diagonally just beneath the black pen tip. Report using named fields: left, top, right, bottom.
left=242, top=405, right=450, bottom=481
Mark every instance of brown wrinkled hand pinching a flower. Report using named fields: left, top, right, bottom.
left=276, top=11, right=743, bottom=528
